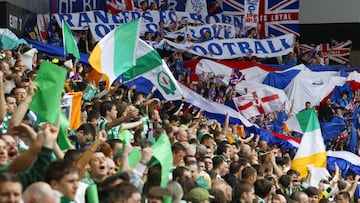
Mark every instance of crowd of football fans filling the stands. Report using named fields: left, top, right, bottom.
left=0, top=0, right=360, bottom=203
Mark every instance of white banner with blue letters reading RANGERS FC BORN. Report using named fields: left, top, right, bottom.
left=55, top=11, right=243, bottom=30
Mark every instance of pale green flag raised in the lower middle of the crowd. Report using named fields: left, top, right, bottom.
left=151, top=134, right=173, bottom=188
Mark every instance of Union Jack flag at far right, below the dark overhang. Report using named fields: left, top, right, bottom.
left=300, top=40, right=352, bottom=64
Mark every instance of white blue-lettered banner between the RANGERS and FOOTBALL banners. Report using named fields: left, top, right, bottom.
left=89, top=23, right=235, bottom=41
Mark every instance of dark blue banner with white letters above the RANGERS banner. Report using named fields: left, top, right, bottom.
left=56, top=0, right=105, bottom=13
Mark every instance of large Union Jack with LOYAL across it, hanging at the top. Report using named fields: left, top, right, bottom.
left=223, top=0, right=300, bottom=37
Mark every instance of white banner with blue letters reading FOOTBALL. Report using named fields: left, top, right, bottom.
left=156, top=34, right=294, bottom=59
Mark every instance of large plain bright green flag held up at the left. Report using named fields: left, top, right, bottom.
left=29, top=61, right=67, bottom=124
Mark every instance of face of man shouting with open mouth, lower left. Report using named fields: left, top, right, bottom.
left=90, top=152, right=108, bottom=179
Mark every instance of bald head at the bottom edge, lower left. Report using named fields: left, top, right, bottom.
left=23, top=182, right=55, bottom=203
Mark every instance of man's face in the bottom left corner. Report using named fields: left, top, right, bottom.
left=0, top=182, right=22, bottom=203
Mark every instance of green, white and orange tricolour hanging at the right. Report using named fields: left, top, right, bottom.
left=285, top=108, right=326, bottom=177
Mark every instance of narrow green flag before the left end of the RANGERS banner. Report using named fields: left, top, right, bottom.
left=62, top=20, right=80, bottom=59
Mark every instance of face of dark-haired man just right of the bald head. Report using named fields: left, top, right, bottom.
left=55, top=172, right=79, bottom=200
